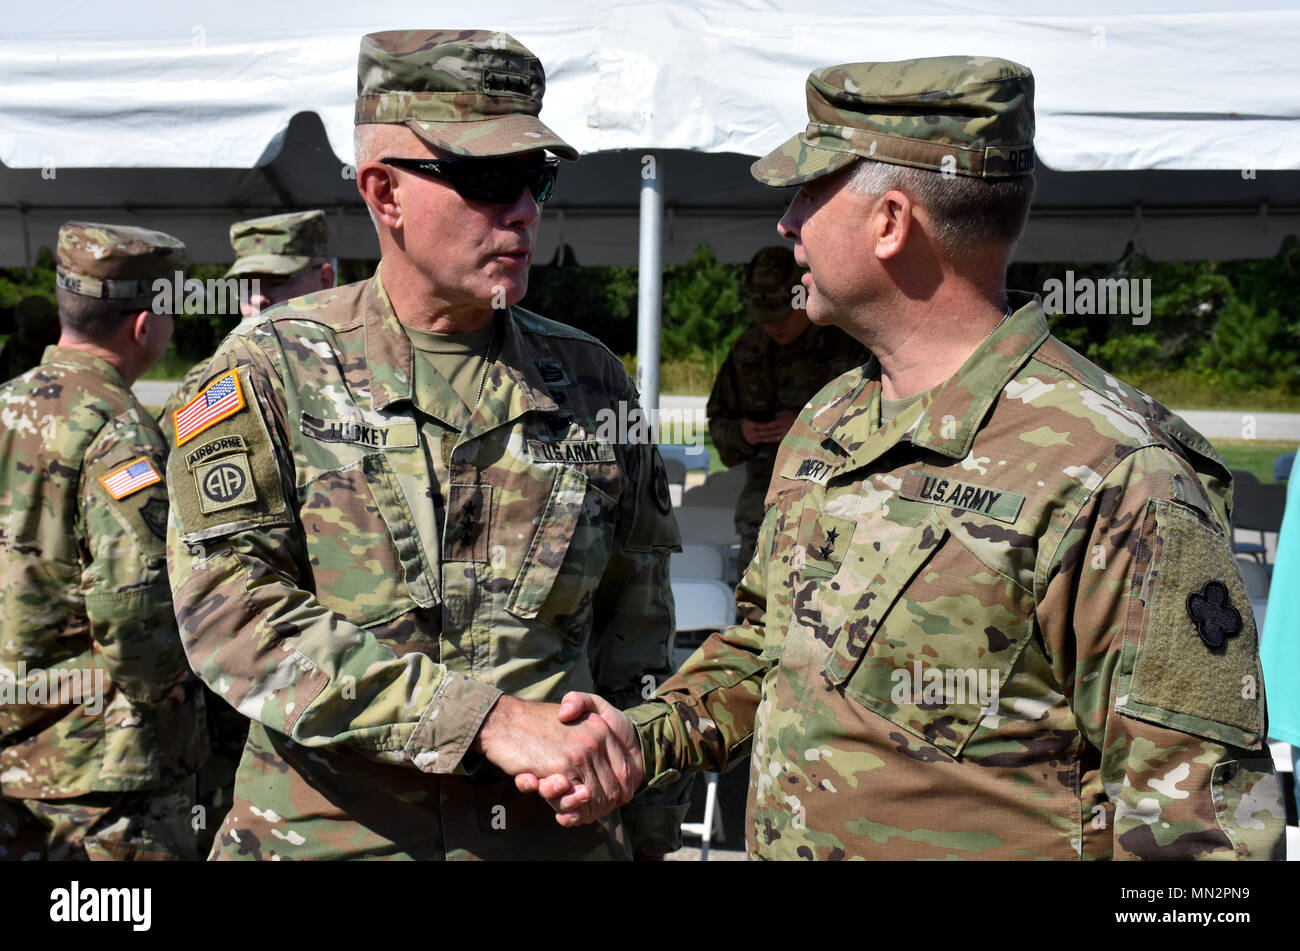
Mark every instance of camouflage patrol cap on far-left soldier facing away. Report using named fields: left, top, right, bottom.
left=55, top=221, right=185, bottom=301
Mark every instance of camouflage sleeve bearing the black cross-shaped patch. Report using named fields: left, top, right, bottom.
left=1036, top=446, right=1283, bottom=859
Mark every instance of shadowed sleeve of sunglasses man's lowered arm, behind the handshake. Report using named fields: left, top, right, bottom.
left=592, top=381, right=690, bottom=855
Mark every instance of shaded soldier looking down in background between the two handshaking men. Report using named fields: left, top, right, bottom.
left=706, top=247, right=871, bottom=568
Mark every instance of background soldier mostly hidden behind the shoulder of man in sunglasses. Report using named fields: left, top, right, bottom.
left=159, top=210, right=334, bottom=854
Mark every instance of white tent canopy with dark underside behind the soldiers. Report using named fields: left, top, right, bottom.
left=0, top=0, right=1300, bottom=265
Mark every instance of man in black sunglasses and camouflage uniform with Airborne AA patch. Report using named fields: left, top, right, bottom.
left=168, top=31, right=683, bottom=860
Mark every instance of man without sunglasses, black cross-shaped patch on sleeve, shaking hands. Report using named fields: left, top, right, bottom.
left=542, top=57, right=1283, bottom=860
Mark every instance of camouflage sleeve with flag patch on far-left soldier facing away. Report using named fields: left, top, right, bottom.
left=81, top=411, right=190, bottom=703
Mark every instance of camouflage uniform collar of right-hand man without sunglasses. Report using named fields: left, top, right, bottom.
left=810, top=291, right=1048, bottom=459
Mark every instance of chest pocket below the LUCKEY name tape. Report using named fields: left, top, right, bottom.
left=298, top=452, right=438, bottom=626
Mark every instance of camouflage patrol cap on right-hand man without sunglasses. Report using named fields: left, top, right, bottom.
left=750, top=56, right=1034, bottom=187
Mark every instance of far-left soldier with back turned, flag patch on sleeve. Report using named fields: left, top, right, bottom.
left=0, top=222, right=207, bottom=859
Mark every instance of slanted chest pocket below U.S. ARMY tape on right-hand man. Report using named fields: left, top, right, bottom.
left=822, top=512, right=1034, bottom=756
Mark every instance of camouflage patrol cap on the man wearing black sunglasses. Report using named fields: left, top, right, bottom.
left=356, top=30, right=577, bottom=159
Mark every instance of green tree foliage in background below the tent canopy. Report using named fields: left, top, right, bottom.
left=0, top=236, right=1300, bottom=408
